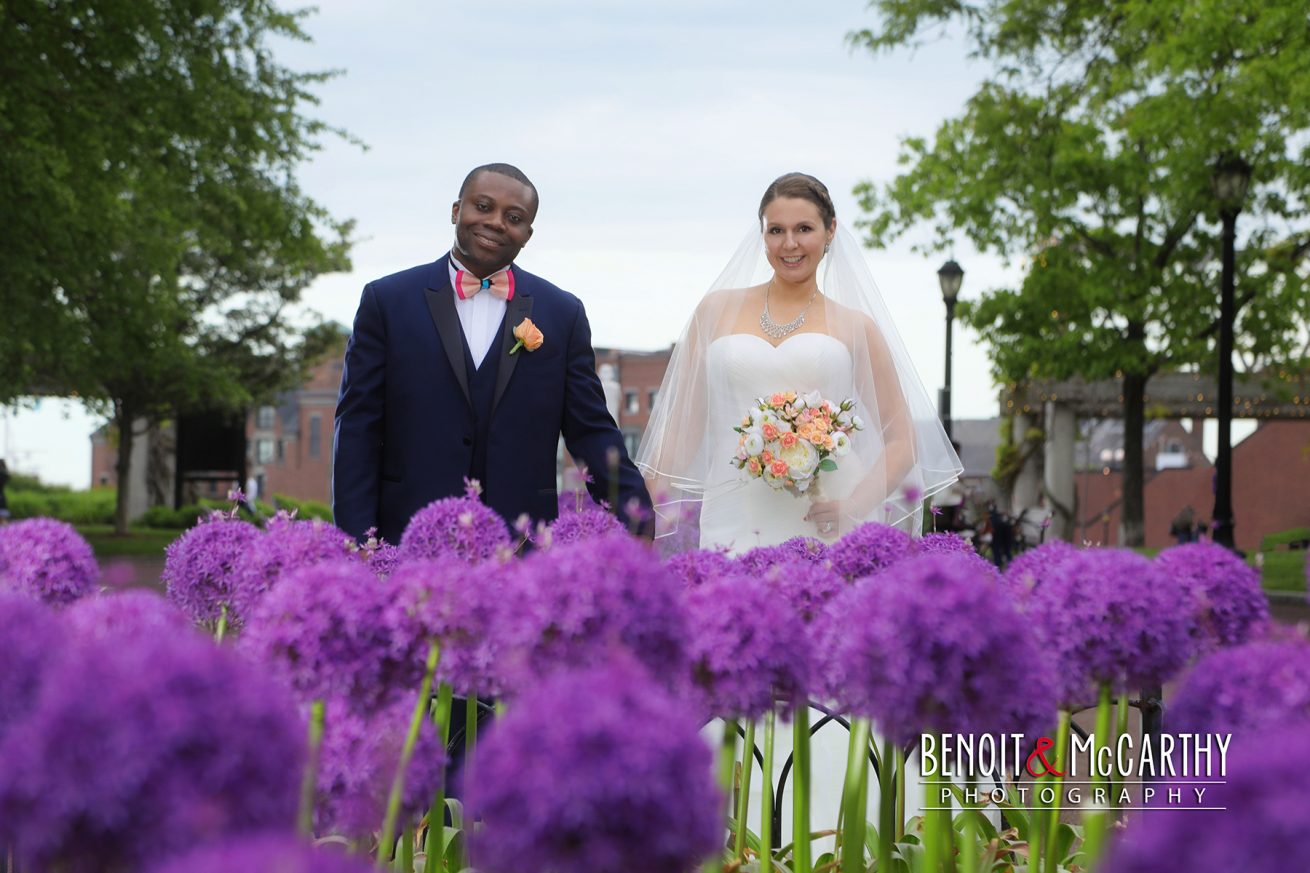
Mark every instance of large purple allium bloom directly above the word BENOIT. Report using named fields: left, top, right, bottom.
left=823, top=554, right=1056, bottom=743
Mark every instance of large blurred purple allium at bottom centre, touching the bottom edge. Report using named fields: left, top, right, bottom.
left=469, top=657, right=723, bottom=873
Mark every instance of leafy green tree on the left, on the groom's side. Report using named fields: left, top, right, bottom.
left=0, top=0, right=350, bottom=531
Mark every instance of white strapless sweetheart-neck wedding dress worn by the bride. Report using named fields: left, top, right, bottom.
left=701, top=332, right=855, bottom=553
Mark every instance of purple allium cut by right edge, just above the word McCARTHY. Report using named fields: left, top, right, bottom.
left=1169, top=637, right=1310, bottom=734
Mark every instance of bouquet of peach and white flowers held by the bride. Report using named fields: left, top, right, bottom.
left=732, top=391, right=865, bottom=494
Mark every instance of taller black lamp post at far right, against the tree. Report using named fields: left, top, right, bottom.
left=1210, top=155, right=1251, bottom=548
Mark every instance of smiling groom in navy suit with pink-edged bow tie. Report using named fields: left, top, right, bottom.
left=333, top=164, right=651, bottom=544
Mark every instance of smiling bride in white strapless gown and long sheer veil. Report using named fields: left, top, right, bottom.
left=637, top=173, right=960, bottom=553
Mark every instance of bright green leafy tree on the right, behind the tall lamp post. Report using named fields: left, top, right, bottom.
left=850, top=0, right=1310, bottom=545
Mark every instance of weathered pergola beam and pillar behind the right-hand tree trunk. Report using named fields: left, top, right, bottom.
left=1001, top=370, right=1310, bottom=540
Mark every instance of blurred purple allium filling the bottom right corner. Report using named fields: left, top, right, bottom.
left=1102, top=721, right=1310, bottom=873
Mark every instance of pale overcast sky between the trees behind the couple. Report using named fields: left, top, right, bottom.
left=0, top=0, right=1018, bottom=486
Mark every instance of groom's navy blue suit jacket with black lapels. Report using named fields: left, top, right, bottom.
left=333, top=256, right=650, bottom=543
